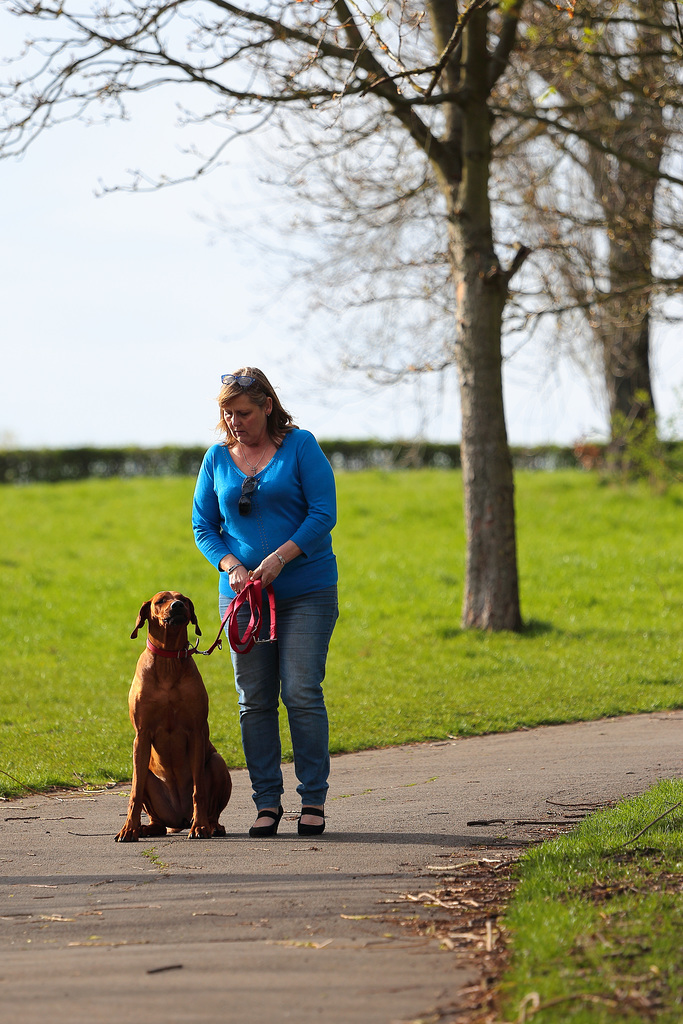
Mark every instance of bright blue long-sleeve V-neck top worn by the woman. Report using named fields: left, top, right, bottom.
left=193, top=429, right=337, bottom=598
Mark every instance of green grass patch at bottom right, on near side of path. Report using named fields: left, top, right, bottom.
left=501, top=781, right=683, bottom=1024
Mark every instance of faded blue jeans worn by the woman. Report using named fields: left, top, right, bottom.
left=219, top=587, right=339, bottom=810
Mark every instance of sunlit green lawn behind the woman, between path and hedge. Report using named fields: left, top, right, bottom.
left=0, top=470, right=683, bottom=794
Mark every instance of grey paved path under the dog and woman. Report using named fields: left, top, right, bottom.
left=0, top=712, right=683, bottom=1024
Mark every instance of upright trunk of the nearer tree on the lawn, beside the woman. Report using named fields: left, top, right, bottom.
left=441, top=13, right=521, bottom=630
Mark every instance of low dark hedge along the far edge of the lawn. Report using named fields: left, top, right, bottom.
left=0, top=440, right=589, bottom=483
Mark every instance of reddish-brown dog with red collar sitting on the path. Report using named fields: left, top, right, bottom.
left=116, top=590, right=232, bottom=843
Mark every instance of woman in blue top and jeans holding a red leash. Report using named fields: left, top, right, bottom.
left=193, top=367, right=339, bottom=837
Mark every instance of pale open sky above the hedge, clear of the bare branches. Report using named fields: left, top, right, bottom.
left=0, top=22, right=683, bottom=447
